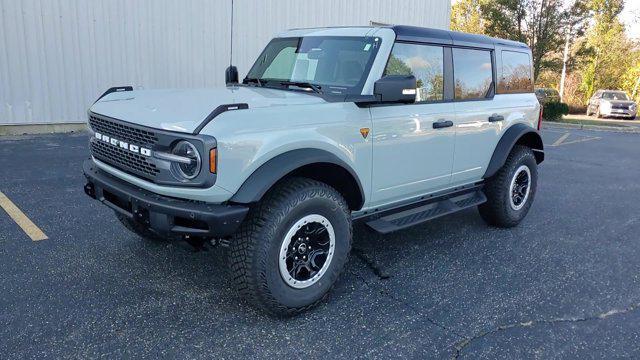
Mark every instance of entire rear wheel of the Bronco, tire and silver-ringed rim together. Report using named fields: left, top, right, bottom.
left=478, top=145, right=538, bottom=227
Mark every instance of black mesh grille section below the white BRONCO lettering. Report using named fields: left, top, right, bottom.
left=91, top=139, right=160, bottom=179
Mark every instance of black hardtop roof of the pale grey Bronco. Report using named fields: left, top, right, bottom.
left=391, top=25, right=529, bottom=50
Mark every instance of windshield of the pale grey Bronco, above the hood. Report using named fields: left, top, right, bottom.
left=243, top=36, right=380, bottom=95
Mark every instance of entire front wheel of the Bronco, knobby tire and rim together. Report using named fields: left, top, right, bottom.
left=230, top=178, right=352, bottom=315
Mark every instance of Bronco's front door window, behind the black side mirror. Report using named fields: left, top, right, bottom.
left=384, top=43, right=444, bottom=102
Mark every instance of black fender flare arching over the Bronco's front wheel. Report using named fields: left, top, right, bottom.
left=230, top=149, right=364, bottom=206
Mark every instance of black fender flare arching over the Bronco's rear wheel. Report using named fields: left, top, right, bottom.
left=482, top=123, right=544, bottom=179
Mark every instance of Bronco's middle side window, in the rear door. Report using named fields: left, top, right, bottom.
left=452, top=48, right=493, bottom=100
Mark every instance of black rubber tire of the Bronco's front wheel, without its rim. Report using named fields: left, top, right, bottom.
left=229, top=178, right=352, bottom=316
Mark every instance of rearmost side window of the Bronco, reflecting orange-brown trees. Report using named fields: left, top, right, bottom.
left=498, top=50, right=532, bottom=95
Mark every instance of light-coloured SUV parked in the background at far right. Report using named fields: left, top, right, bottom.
left=587, top=90, right=638, bottom=120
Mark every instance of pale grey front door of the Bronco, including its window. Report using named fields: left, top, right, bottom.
left=370, top=42, right=455, bottom=206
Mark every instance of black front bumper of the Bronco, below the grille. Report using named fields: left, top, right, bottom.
left=82, top=160, right=249, bottom=237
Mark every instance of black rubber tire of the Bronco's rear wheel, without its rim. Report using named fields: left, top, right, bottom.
left=478, top=145, right=538, bottom=228
